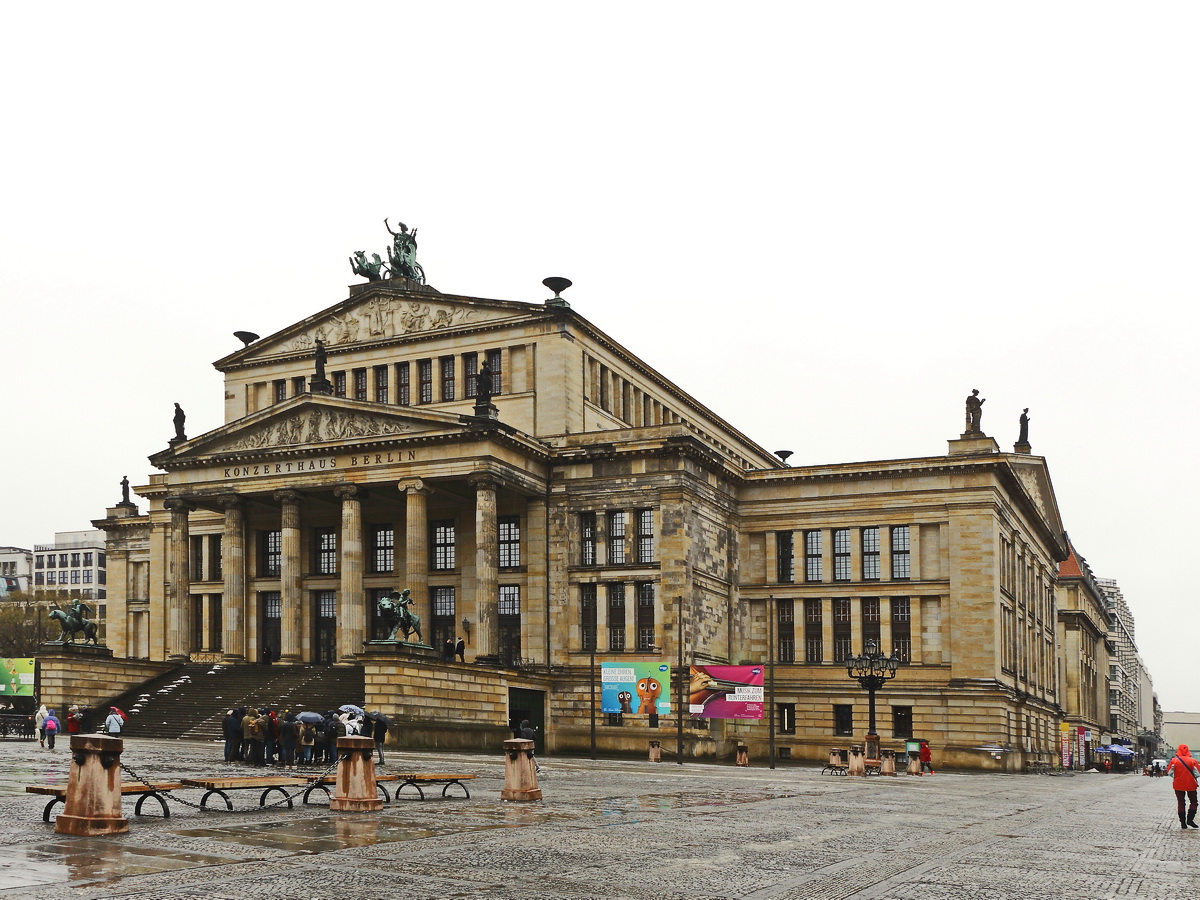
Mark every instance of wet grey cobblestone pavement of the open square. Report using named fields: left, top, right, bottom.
left=0, top=738, right=1200, bottom=900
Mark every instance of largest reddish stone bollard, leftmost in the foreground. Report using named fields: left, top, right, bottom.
left=54, top=734, right=130, bottom=835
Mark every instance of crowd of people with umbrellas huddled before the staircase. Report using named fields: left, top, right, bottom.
left=221, top=707, right=388, bottom=769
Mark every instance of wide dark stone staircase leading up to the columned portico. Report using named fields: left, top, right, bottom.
left=112, top=665, right=364, bottom=740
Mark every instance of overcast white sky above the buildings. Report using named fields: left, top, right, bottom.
left=0, top=1, right=1200, bottom=710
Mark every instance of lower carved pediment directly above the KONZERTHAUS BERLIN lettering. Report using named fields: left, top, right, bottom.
left=151, top=394, right=463, bottom=468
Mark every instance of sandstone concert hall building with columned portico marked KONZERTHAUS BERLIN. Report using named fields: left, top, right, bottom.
left=95, top=259, right=1067, bottom=768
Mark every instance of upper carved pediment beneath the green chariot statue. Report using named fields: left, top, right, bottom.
left=215, top=282, right=545, bottom=370
